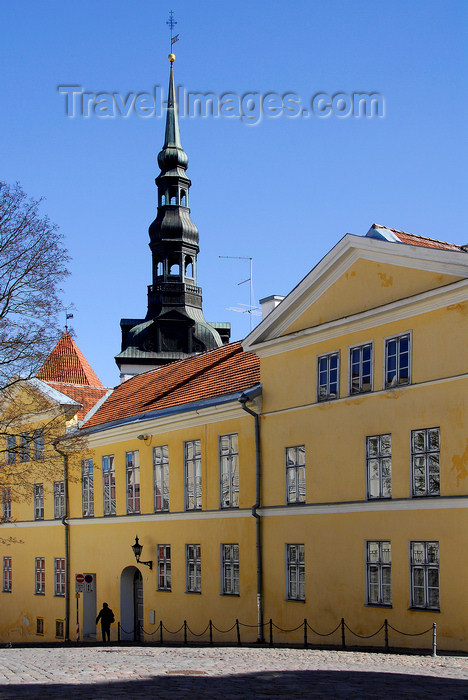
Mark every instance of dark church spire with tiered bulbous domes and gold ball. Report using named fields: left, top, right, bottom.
left=115, top=41, right=230, bottom=377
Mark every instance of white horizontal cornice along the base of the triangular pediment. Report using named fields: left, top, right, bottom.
left=248, top=280, right=468, bottom=357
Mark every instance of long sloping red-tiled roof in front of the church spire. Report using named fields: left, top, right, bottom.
left=84, top=342, right=260, bottom=428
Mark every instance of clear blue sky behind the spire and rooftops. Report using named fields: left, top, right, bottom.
left=0, top=0, right=468, bottom=385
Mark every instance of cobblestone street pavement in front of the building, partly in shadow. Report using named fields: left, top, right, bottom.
left=0, top=644, right=468, bottom=700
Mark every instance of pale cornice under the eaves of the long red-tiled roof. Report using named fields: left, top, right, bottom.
left=87, top=401, right=246, bottom=448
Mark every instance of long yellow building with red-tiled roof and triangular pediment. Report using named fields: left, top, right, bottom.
left=0, top=226, right=468, bottom=651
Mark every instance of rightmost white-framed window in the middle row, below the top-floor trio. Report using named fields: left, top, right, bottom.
left=411, top=428, right=440, bottom=496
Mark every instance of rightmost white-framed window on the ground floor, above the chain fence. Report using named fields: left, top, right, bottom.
left=410, top=542, right=440, bottom=610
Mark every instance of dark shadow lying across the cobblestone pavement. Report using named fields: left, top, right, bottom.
left=0, top=669, right=468, bottom=700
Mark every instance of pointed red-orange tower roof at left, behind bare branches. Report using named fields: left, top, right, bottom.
left=36, top=331, right=103, bottom=387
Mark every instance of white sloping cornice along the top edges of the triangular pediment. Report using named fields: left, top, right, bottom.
left=242, top=234, right=468, bottom=352
